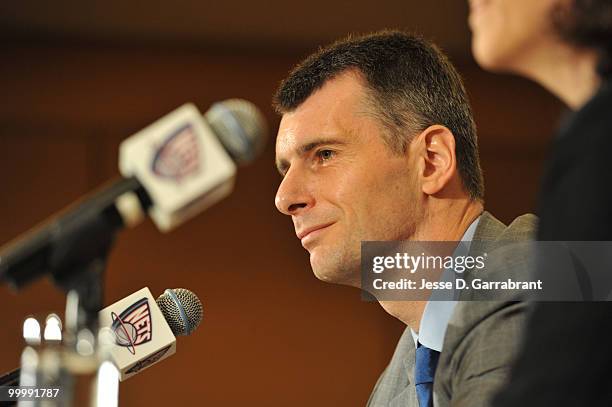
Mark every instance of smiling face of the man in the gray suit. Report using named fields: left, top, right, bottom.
left=276, top=72, right=422, bottom=286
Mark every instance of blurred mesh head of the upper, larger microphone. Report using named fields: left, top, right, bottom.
left=204, top=99, right=268, bottom=164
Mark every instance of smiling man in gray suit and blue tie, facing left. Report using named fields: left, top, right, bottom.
left=275, top=32, right=533, bottom=407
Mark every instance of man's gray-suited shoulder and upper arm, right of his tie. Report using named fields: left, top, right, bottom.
left=434, top=212, right=538, bottom=406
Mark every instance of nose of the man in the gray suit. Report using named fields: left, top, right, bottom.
left=274, top=168, right=314, bottom=215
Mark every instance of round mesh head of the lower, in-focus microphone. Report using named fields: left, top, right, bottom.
left=156, top=288, right=204, bottom=336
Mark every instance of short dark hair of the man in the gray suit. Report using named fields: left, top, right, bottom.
left=273, top=31, right=484, bottom=199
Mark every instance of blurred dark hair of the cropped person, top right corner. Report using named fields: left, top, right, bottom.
left=553, top=0, right=612, bottom=77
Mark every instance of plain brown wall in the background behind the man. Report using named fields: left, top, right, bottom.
left=0, top=39, right=559, bottom=406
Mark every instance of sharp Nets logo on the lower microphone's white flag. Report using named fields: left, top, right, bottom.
left=111, top=297, right=153, bottom=355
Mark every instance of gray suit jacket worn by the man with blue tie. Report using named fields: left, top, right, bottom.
left=368, top=212, right=536, bottom=407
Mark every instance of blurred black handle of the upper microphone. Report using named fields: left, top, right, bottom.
left=0, top=177, right=151, bottom=289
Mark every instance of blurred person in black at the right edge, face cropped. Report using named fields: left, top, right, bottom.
left=469, top=0, right=612, bottom=406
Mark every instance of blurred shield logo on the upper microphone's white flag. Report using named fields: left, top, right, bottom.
left=152, top=124, right=200, bottom=182
